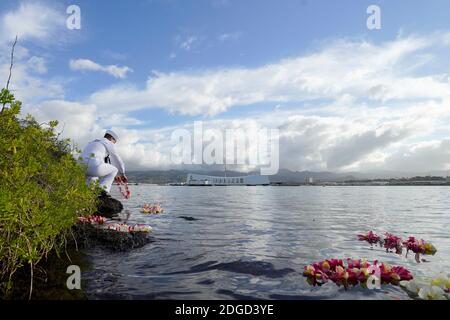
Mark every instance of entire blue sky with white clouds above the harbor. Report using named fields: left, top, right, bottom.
left=0, top=0, right=450, bottom=171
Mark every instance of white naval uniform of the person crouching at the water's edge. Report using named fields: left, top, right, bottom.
left=81, top=138, right=125, bottom=192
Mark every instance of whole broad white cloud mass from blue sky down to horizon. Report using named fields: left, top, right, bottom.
left=6, top=26, right=450, bottom=171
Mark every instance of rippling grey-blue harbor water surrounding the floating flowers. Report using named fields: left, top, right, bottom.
left=83, top=185, right=450, bottom=299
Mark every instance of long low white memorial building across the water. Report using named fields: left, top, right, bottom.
left=186, top=173, right=270, bottom=186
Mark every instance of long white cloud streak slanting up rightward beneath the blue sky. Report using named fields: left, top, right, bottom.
left=90, top=35, right=450, bottom=115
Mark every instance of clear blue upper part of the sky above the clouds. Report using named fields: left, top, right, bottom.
left=25, top=0, right=450, bottom=107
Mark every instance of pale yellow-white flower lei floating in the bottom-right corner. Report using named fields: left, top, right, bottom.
left=400, top=274, right=450, bottom=300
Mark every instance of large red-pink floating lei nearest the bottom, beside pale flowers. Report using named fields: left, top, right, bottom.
left=303, top=258, right=413, bottom=289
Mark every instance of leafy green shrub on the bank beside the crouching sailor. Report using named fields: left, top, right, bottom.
left=0, top=89, right=97, bottom=297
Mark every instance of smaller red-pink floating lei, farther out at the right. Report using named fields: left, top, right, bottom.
left=358, top=231, right=437, bottom=262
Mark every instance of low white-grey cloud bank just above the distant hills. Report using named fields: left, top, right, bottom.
left=27, top=95, right=450, bottom=171
